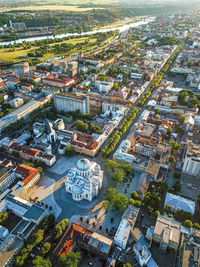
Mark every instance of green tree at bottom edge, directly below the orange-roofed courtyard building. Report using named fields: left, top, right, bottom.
left=57, top=251, right=81, bottom=267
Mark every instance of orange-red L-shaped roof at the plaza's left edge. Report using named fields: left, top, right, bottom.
left=16, top=164, right=39, bottom=185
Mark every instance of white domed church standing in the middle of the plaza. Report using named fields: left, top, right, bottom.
left=65, top=158, right=103, bottom=201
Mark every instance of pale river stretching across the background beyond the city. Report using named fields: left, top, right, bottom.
left=0, top=17, right=155, bottom=45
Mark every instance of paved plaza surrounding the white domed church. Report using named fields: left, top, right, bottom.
left=23, top=155, right=145, bottom=240
